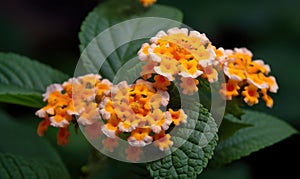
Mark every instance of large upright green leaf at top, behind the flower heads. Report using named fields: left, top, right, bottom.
left=75, top=1, right=182, bottom=80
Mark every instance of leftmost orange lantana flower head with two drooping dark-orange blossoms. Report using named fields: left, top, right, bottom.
left=35, top=74, right=112, bottom=146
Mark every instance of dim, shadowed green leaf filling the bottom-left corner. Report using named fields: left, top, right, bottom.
left=0, top=111, right=70, bottom=178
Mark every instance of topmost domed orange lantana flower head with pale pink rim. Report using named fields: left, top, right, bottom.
left=138, top=28, right=218, bottom=95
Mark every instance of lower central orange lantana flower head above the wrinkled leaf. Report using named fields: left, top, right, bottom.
left=100, top=79, right=187, bottom=151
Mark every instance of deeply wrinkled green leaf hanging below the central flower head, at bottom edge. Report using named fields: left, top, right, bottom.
left=147, top=99, right=217, bottom=178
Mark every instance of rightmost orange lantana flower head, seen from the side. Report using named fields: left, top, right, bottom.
left=216, top=48, right=278, bottom=108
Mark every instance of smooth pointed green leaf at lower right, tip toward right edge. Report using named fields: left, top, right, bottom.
left=210, top=110, right=297, bottom=167
